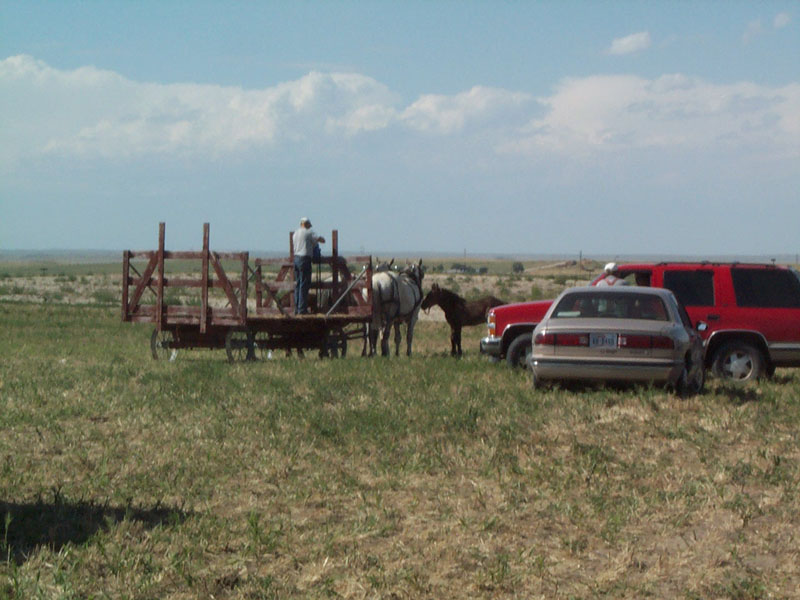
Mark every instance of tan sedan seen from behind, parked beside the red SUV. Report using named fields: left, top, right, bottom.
left=528, top=287, right=705, bottom=395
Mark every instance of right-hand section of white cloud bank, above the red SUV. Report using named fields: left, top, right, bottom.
left=502, top=75, right=800, bottom=157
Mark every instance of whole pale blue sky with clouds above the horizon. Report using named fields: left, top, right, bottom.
left=0, top=0, right=800, bottom=256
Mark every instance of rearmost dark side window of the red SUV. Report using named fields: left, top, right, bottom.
left=731, top=268, right=800, bottom=308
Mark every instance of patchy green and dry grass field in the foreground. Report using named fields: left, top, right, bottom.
left=0, top=271, right=800, bottom=599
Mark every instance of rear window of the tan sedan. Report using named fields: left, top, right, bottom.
left=552, top=292, right=669, bottom=321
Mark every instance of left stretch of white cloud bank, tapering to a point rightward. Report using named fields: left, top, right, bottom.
left=0, top=56, right=530, bottom=159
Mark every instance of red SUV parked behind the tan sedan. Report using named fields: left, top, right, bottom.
left=480, top=262, right=800, bottom=381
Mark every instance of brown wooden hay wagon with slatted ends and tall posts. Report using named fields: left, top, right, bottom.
left=122, top=223, right=372, bottom=362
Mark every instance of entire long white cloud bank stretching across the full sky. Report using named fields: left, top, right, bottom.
left=0, top=56, right=800, bottom=168
